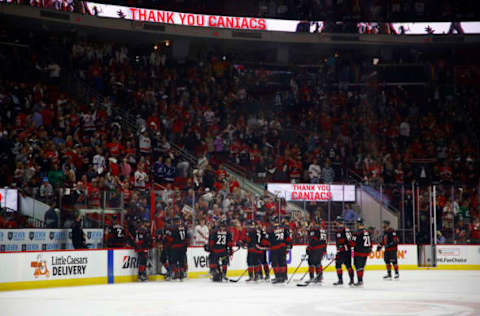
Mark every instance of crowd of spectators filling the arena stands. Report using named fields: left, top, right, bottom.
left=0, top=27, right=480, bottom=244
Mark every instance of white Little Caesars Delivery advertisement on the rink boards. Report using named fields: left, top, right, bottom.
left=0, top=251, right=107, bottom=285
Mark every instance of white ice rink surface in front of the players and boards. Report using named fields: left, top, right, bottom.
left=0, top=270, right=480, bottom=316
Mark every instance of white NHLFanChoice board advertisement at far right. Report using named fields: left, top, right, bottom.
left=436, top=245, right=480, bottom=268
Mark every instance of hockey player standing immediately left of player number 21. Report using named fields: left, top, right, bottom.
left=333, top=216, right=353, bottom=285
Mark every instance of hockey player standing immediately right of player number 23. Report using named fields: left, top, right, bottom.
left=242, top=221, right=263, bottom=282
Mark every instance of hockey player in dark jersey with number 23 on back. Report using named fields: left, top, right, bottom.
left=205, top=221, right=233, bottom=282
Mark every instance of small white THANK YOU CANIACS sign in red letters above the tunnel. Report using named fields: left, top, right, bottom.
left=267, top=183, right=355, bottom=202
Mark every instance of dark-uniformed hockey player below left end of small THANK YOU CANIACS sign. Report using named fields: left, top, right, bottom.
left=264, top=217, right=291, bottom=283
